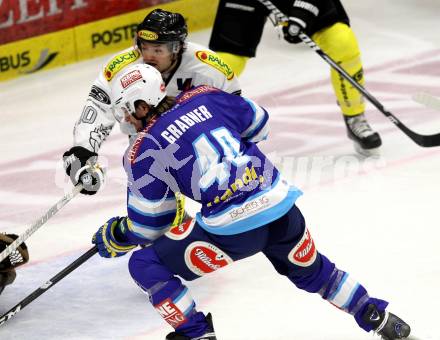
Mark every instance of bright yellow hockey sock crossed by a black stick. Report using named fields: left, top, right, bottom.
left=312, top=23, right=365, bottom=116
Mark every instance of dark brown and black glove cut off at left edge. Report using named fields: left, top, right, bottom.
left=0, top=233, right=29, bottom=294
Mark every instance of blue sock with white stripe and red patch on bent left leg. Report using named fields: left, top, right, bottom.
left=129, top=247, right=208, bottom=338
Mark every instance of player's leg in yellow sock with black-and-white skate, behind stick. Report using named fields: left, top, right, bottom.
left=308, top=0, right=382, bottom=156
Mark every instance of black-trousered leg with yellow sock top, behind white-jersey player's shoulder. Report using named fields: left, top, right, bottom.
left=209, top=0, right=267, bottom=75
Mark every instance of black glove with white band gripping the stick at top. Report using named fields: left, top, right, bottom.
left=283, top=0, right=319, bottom=44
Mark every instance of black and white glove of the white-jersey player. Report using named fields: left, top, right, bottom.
left=63, top=146, right=104, bottom=195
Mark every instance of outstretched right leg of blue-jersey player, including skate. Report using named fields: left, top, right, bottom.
left=263, top=207, right=410, bottom=340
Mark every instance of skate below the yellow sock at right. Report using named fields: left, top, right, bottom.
left=344, top=113, right=382, bottom=156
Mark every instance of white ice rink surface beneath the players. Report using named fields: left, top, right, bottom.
left=0, top=0, right=440, bottom=340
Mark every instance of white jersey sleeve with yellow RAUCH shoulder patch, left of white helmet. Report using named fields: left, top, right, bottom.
left=73, top=48, right=142, bottom=153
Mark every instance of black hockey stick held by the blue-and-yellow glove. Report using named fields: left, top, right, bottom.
left=0, top=246, right=98, bottom=326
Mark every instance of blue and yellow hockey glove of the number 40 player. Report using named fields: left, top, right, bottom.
left=92, top=216, right=137, bottom=258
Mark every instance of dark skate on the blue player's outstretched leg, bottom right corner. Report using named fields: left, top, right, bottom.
left=363, top=304, right=411, bottom=340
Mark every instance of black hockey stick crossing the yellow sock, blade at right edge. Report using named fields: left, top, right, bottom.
left=257, top=0, right=440, bottom=147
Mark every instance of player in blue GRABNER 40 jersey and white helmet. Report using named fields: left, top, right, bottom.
left=93, top=64, right=410, bottom=340
